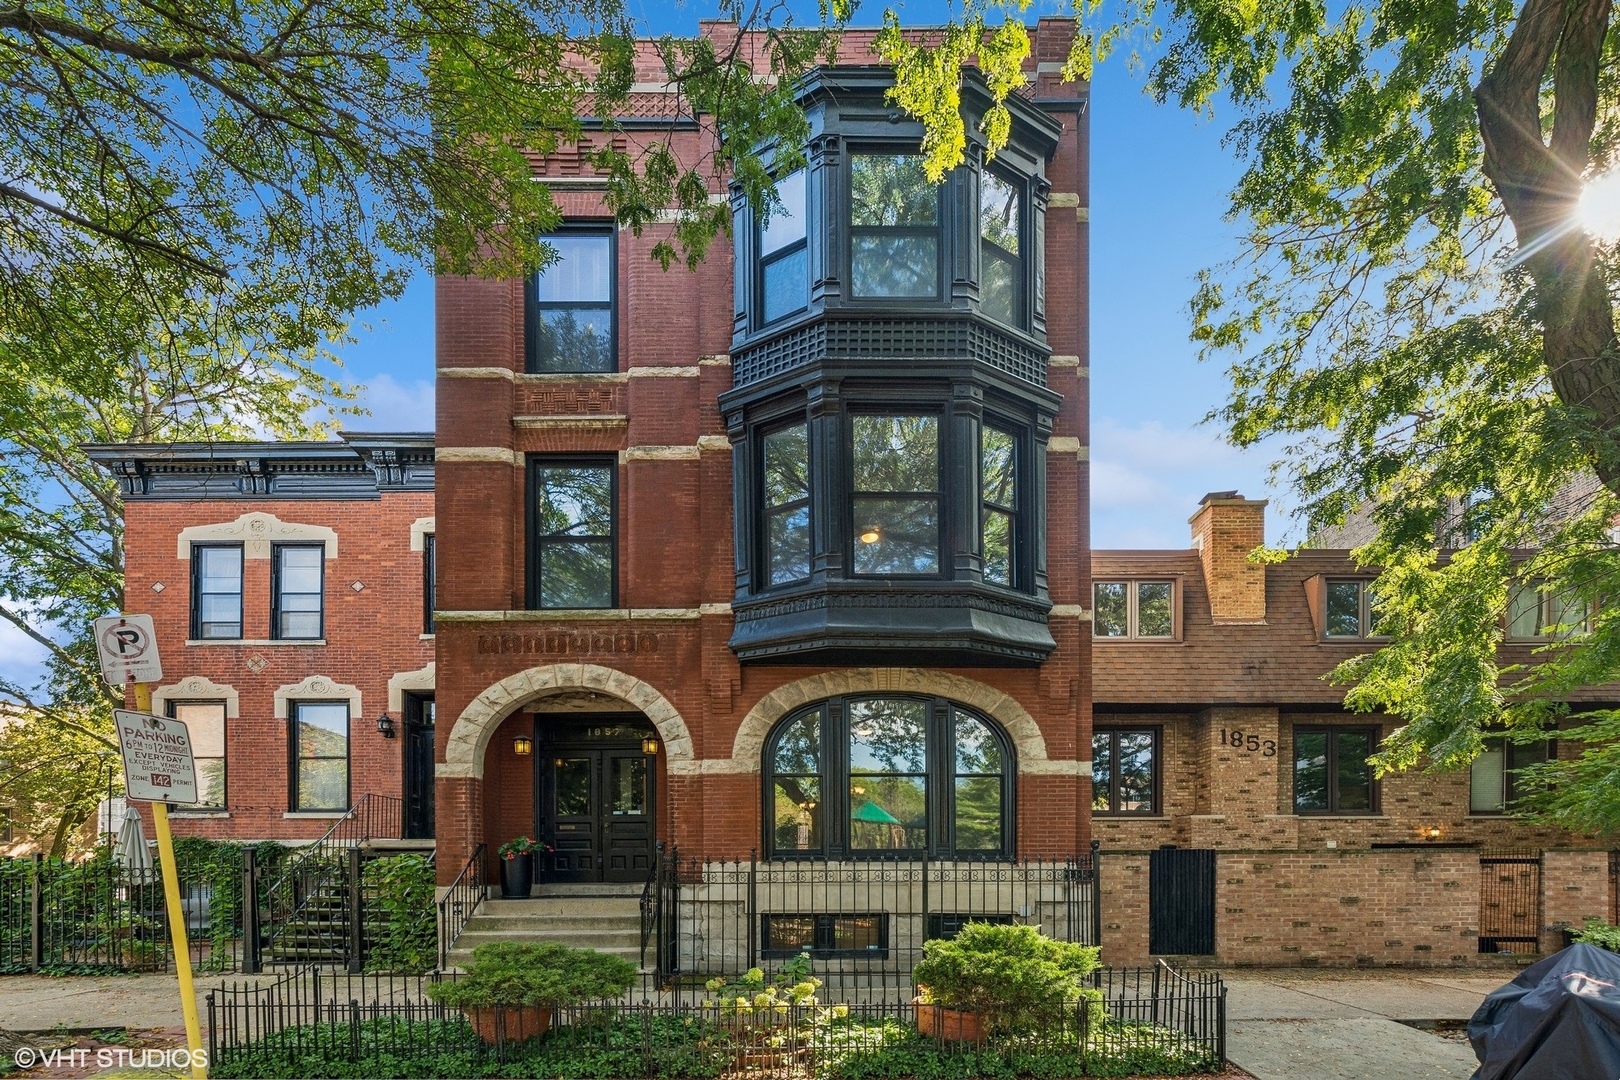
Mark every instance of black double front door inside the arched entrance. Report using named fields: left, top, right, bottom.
left=536, top=724, right=656, bottom=881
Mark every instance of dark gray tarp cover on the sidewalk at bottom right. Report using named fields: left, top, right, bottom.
left=1468, top=944, right=1620, bottom=1080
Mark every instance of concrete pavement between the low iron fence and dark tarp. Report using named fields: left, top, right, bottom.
left=1226, top=972, right=1513, bottom=1080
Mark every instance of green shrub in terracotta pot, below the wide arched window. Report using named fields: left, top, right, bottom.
left=912, top=921, right=1102, bottom=1043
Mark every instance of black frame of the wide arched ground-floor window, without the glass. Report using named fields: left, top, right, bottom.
left=760, top=691, right=1017, bottom=861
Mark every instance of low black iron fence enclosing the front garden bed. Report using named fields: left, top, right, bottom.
left=207, top=965, right=1226, bottom=1080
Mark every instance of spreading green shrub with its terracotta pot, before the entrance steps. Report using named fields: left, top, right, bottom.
left=426, top=941, right=635, bottom=1044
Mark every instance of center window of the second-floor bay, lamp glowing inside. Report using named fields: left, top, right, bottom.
left=851, top=416, right=940, bottom=575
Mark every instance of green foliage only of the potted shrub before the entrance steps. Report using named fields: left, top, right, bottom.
left=426, top=941, right=635, bottom=1009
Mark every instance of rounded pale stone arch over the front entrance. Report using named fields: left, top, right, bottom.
left=437, top=664, right=697, bottom=779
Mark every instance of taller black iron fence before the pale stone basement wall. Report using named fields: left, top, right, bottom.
left=643, top=845, right=1102, bottom=991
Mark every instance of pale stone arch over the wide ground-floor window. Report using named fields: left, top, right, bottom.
left=729, top=667, right=1082, bottom=776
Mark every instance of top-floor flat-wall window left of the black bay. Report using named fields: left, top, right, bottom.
left=528, top=230, right=619, bottom=374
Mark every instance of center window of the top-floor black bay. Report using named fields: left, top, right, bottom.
left=849, top=154, right=940, bottom=298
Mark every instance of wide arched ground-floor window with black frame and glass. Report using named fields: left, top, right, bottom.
left=763, top=695, right=1014, bottom=858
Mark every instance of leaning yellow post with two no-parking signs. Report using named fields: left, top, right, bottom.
left=96, top=615, right=207, bottom=1080
